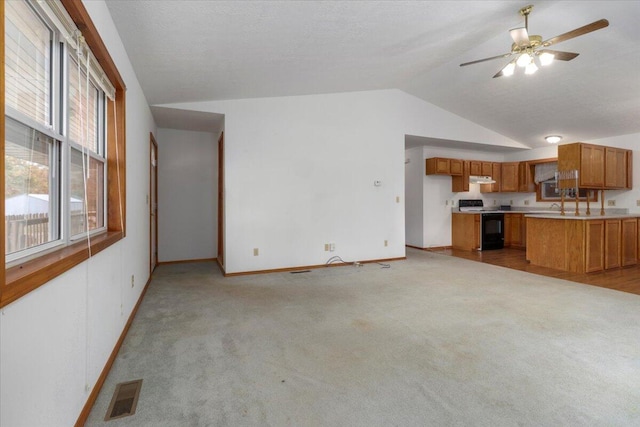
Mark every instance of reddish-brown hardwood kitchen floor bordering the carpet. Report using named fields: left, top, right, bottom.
left=425, top=248, right=640, bottom=295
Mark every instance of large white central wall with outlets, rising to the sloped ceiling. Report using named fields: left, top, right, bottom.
left=156, top=90, right=519, bottom=273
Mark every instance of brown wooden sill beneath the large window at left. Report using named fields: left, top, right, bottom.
left=0, top=231, right=124, bottom=307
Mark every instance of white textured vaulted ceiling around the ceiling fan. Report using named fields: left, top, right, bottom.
left=107, top=0, right=640, bottom=151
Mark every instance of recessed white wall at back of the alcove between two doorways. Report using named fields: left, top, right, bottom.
left=157, top=129, right=218, bottom=262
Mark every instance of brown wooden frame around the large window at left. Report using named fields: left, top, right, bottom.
left=0, top=0, right=126, bottom=307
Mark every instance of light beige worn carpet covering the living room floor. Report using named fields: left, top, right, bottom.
left=87, top=249, right=640, bottom=427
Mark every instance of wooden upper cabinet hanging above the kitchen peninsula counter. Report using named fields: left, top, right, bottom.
left=558, top=142, right=632, bottom=190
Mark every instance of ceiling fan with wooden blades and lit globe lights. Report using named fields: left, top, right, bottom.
left=460, top=5, right=609, bottom=78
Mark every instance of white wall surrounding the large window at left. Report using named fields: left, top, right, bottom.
left=0, top=1, right=154, bottom=427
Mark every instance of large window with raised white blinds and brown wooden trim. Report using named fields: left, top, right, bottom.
left=0, top=0, right=126, bottom=306
